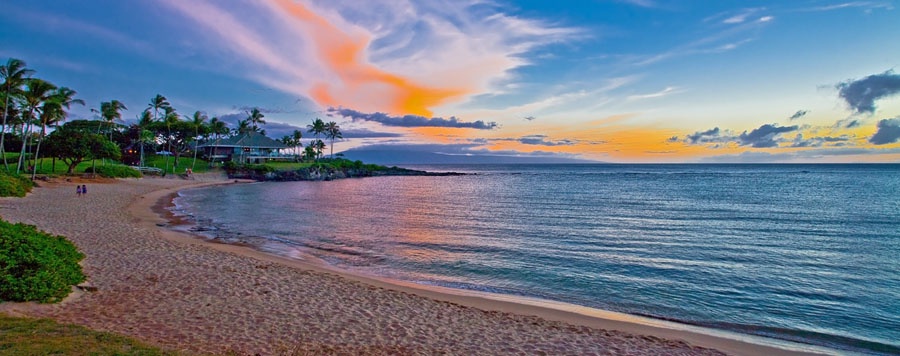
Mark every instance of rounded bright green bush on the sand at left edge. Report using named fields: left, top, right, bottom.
left=0, top=220, right=85, bottom=303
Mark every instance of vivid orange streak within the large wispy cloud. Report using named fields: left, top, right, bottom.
left=276, top=0, right=470, bottom=117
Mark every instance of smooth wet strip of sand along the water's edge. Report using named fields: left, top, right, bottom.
left=150, top=182, right=836, bottom=355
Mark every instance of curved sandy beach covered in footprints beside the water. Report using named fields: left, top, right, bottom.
left=0, top=177, right=824, bottom=355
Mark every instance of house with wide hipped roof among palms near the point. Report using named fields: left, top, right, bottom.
left=197, top=131, right=294, bottom=164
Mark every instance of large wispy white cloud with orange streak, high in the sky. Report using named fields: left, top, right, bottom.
left=159, top=0, right=578, bottom=116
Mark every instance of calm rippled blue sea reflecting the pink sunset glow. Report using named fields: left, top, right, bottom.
left=176, top=165, right=900, bottom=354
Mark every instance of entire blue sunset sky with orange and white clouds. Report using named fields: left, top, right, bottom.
left=0, top=0, right=900, bottom=163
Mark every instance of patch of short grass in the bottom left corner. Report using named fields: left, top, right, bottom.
left=0, top=315, right=175, bottom=355
